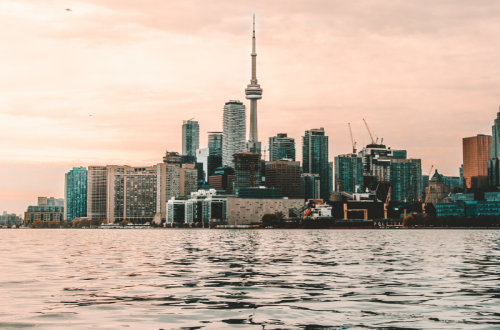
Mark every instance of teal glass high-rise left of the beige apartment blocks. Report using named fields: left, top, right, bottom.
left=64, top=167, right=87, bottom=221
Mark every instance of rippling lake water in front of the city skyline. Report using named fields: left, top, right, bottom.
left=0, top=229, right=500, bottom=329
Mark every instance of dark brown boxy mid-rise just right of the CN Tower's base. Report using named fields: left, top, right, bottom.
left=265, top=160, right=300, bottom=199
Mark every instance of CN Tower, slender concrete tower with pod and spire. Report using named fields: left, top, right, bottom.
left=245, top=15, right=262, bottom=154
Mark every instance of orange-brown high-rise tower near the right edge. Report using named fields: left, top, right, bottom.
left=463, top=134, right=492, bottom=189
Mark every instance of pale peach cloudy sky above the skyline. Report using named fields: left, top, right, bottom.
left=0, top=0, right=500, bottom=214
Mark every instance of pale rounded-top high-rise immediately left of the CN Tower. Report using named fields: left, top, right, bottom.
left=222, top=101, right=246, bottom=167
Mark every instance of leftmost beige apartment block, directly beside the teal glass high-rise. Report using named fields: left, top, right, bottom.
left=87, top=166, right=108, bottom=220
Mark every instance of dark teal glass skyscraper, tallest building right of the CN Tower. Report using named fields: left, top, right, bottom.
left=302, top=127, right=330, bottom=200
